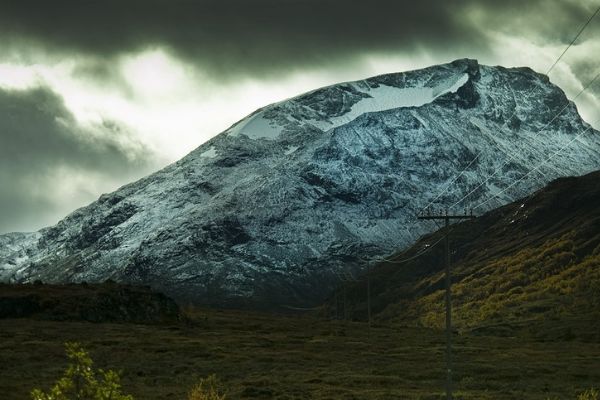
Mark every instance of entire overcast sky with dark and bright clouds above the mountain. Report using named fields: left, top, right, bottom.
left=0, top=0, right=600, bottom=233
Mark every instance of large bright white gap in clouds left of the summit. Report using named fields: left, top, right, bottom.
left=0, top=48, right=379, bottom=162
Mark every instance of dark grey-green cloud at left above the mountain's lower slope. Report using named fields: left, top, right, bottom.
left=0, top=88, right=157, bottom=233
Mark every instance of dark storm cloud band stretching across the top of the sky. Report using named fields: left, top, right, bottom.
left=0, top=0, right=590, bottom=78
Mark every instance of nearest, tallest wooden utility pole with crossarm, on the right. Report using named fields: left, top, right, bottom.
left=418, top=209, right=473, bottom=400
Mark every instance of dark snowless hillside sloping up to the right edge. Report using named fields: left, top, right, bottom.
left=329, top=171, right=600, bottom=342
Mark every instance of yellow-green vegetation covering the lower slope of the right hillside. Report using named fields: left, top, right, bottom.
left=404, top=232, right=600, bottom=341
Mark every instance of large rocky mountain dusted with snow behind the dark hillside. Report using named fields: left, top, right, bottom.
left=0, top=60, right=600, bottom=307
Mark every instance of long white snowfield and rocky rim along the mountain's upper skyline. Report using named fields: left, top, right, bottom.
left=226, top=60, right=477, bottom=140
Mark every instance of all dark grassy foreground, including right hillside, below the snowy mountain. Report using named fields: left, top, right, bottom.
left=0, top=172, right=600, bottom=400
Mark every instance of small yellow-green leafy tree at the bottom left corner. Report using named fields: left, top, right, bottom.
left=31, top=343, right=133, bottom=400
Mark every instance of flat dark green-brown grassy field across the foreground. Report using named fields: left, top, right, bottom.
left=0, top=310, right=600, bottom=400
